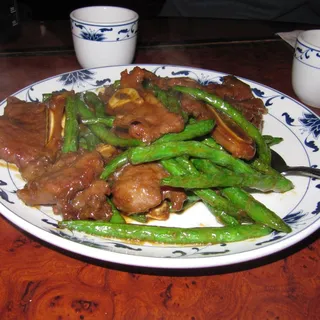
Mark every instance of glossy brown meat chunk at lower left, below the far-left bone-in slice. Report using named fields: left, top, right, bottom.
left=17, top=151, right=111, bottom=219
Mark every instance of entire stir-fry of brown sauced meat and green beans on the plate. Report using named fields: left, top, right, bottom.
left=0, top=67, right=293, bottom=244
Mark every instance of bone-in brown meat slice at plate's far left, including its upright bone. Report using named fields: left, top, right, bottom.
left=0, top=93, right=70, bottom=180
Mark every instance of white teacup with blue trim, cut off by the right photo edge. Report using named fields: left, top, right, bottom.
left=292, top=30, right=320, bottom=108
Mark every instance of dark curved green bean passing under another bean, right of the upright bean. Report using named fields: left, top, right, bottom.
left=76, top=95, right=143, bottom=147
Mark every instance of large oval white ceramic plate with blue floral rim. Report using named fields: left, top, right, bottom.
left=0, top=65, right=320, bottom=269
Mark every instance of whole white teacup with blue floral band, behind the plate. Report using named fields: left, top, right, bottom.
left=70, top=6, right=139, bottom=69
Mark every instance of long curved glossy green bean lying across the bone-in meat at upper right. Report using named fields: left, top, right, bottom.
left=173, top=86, right=271, bottom=164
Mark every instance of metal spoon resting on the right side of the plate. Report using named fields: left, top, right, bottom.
left=271, top=149, right=320, bottom=179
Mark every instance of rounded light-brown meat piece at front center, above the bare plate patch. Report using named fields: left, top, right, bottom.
left=111, top=163, right=168, bottom=214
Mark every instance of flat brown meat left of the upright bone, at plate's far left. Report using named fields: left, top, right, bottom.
left=0, top=97, right=47, bottom=168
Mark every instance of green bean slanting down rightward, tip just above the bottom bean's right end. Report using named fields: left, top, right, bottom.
left=221, top=187, right=291, bottom=233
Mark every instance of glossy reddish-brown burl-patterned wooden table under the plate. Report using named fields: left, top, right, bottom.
left=0, top=18, right=320, bottom=320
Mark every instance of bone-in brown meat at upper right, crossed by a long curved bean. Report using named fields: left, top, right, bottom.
left=181, top=76, right=267, bottom=160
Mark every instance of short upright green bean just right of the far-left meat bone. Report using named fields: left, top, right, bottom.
left=62, top=96, right=79, bottom=153
